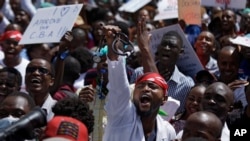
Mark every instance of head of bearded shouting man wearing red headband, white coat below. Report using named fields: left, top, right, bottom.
left=133, top=73, right=168, bottom=117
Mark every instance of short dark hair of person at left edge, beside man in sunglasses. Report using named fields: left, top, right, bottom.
left=0, top=67, right=23, bottom=90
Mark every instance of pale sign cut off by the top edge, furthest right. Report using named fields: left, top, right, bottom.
left=201, top=0, right=247, bottom=9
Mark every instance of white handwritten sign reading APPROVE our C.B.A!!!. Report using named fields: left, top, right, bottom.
left=19, top=4, right=83, bottom=44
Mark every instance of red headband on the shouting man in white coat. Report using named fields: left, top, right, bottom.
left=135, top=72, right=168, bottom=95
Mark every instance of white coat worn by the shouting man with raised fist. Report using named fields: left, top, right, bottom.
left=103, top=56, right=176, bottom=141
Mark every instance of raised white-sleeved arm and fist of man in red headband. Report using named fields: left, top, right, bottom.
left=103, top=25, right=131, bottom=117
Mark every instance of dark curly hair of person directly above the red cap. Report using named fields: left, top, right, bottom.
left=52, top=98, right=94, bottom=133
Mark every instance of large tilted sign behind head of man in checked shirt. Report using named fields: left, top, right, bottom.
left=150, top=24, right=204, bottom=78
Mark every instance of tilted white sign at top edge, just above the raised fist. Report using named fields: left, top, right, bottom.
left=118, top=0, right=151, bottom=13
